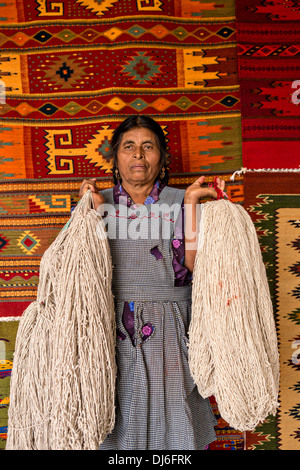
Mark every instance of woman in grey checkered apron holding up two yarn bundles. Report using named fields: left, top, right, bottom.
left=79, top=116, right=225, bottom=450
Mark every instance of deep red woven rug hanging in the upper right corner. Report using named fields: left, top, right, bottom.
left=236, top=0, right=300, bottom=168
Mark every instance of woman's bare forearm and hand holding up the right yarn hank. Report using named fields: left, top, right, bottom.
left=184, top=176, right=225, bottom=272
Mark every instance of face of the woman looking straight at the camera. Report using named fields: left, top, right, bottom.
left=117, top=127, right=161, bottom=188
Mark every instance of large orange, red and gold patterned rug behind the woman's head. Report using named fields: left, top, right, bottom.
left=0, top=0, right=242, bottom=179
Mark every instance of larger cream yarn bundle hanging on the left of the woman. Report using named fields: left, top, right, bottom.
left=6, top=191, right=116, bottom=450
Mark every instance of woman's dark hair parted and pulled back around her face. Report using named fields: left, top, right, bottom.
left=110, top=115, right=170, bottom=184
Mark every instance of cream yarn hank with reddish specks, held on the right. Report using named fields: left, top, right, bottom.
left=189, top=199, right=279, bottom=431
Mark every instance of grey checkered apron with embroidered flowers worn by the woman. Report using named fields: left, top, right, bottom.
left=100, top=187, right=217, bottom=450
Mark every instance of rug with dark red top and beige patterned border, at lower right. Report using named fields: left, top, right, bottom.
left=245, top=172, right=300, bottom=450
